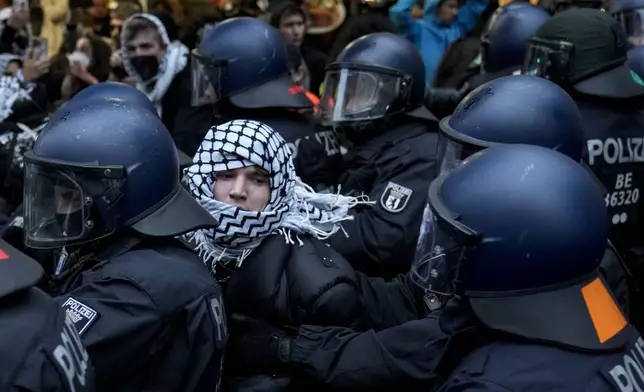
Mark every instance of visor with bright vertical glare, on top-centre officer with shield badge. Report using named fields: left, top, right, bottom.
left=318, top=65, right=411, bottom=125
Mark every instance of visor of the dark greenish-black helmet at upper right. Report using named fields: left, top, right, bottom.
left=521, top=38, right=574, bottom=83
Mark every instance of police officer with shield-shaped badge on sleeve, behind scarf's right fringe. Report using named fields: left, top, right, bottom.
left=319, top=33, right=437, bottom=276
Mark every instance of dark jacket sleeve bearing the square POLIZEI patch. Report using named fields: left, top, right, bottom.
left=55, top=278, right=162, bottom=378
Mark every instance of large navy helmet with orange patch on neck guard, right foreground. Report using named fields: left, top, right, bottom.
left=411, top=145, right=625, bottom=349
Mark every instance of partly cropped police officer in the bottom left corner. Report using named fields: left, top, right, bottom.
left=0, top=237, right=94, bottom=392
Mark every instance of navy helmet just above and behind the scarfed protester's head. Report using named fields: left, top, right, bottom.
left=191, top=17, right=313, bottom=109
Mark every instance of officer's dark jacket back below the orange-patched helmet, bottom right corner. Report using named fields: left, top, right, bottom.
left=443, top=326, right=644, bottom=392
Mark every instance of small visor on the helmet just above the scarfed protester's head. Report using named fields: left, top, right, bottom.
left=190, top=49, right=227, bottom=106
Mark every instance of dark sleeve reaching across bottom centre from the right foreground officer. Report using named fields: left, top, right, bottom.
left=289, top=316, right=449, bottom=390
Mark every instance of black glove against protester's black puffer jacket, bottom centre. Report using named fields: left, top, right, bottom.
left=226, top=313, right=295, bottom=375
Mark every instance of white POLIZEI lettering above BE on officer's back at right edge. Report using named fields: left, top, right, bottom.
left=586, top=137, right=644, bottom=166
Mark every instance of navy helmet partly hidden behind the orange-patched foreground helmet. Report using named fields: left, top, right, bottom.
left=437, top=75, right=586, bottom=173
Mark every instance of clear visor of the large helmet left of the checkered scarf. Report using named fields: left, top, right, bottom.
left=24, top=155, right=124, bottom=249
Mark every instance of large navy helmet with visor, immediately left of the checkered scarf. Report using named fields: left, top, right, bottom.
left=24, top=100, right=217, bottom=248
